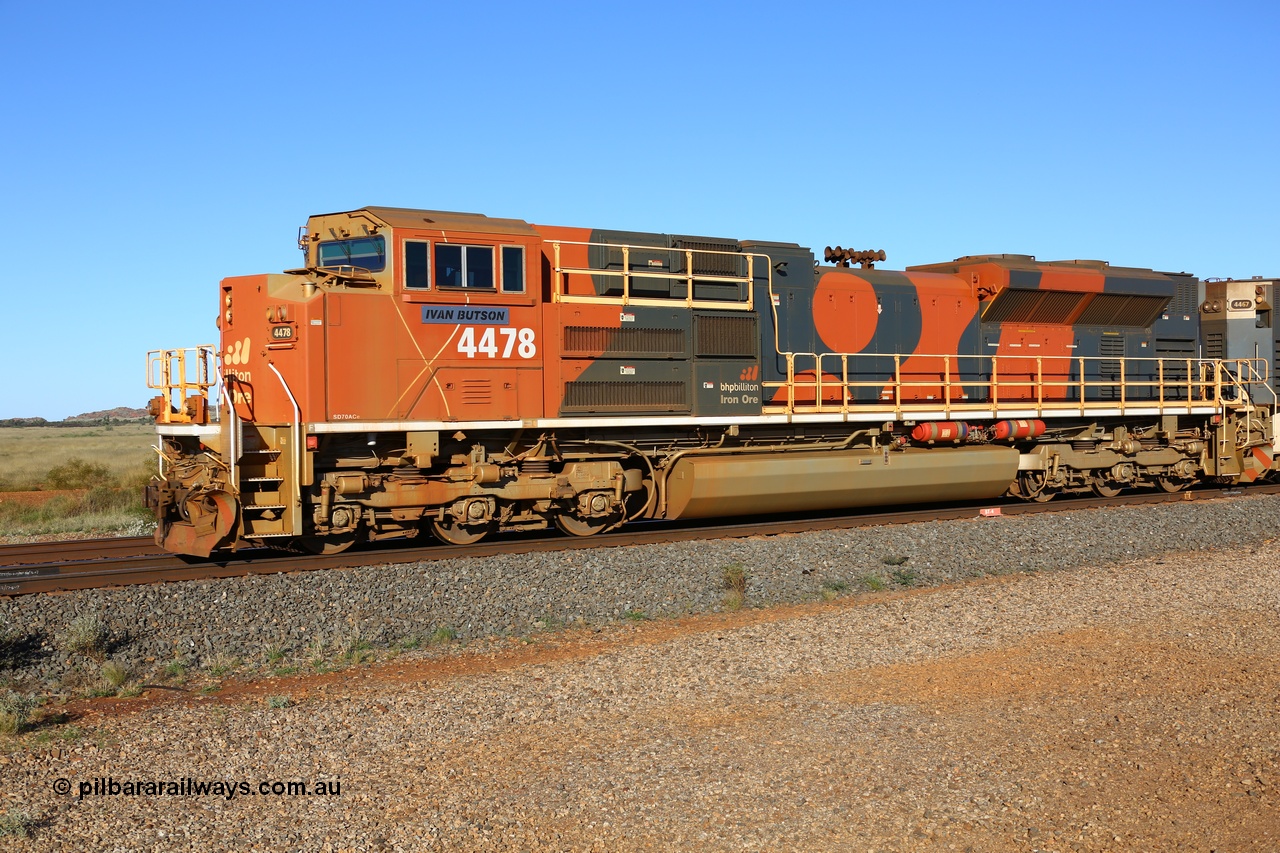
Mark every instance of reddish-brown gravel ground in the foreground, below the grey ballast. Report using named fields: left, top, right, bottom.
left=0, top=514, right=1280, bottom=853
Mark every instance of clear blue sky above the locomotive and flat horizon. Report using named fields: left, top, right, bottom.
left=0, top=0, right=1280, bottom=419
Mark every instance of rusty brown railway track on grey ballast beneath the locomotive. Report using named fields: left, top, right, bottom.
left=0, top=485, right=1280, bottom=596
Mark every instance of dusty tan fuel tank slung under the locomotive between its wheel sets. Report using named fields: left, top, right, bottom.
left=666, top=446, right=1018, bottom=519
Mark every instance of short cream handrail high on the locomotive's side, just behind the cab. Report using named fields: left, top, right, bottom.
left=549, top=240, right=757, bottom=311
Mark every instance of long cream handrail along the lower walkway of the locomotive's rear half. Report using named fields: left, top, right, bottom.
left=762, top=352, right=1276, bottom=420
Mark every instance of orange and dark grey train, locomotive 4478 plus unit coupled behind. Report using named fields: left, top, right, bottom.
left=145, top=207, right=1280, bottom=557
